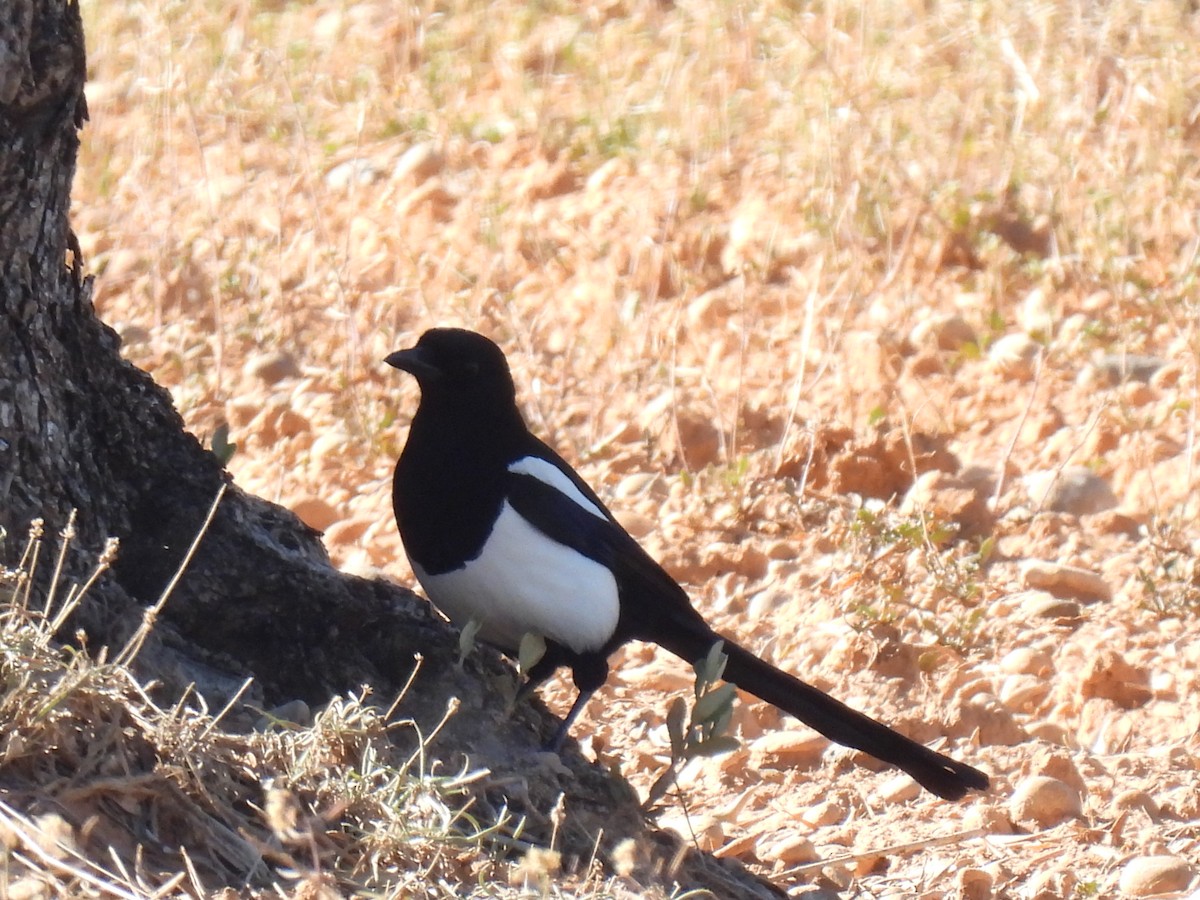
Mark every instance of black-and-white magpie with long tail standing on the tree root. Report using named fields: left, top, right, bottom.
left=385, top=328, right=988, bottom=799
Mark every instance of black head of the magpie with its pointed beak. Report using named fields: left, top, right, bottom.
left=384, top=328, right=516, bottom=407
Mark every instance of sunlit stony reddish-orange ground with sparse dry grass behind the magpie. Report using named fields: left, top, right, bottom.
left=49, top=0, right=1200, bottom=895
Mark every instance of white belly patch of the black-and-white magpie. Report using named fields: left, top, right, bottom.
left=412, top=502, right=620, bottom=653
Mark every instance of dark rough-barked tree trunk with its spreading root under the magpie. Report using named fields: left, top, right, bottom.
left=0, top=0, right=782, bottom=896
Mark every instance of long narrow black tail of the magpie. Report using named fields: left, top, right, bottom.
left=658, top=629, right=988, bottom=800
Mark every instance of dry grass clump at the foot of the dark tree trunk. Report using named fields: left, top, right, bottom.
left=0, top=526, right=657, bottom=900
